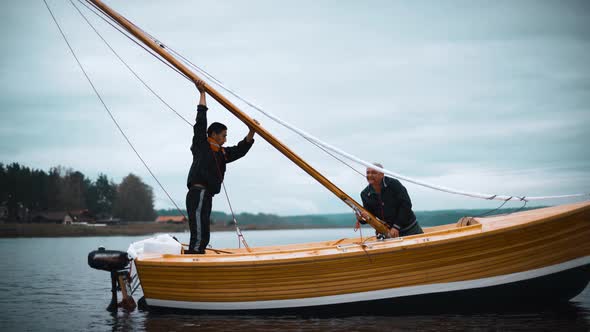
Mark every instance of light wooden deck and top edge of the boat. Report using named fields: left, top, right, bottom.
left=139, top=201, right=590, bottom=265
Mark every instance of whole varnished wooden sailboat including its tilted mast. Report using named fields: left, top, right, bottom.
left=84, top=0, right=590, bottom=313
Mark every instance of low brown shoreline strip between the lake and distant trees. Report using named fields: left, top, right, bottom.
left=0, top=222, right=338, bottom=238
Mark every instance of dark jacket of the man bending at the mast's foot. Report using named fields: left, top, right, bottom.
left=361, top=177, right=416, bottom=230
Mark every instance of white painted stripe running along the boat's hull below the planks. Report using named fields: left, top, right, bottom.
left=146, top=256, right=590, bottom=310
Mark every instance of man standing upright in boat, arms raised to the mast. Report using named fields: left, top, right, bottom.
left=185, top=80, right=258, bottom=254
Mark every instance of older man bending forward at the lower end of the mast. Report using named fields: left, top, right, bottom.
left=359, top=163, right=424, bottom=237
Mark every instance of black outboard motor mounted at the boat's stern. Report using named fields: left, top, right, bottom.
left=88, top=247, right=137, bottom=311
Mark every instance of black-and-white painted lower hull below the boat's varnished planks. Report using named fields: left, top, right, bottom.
left=145, top=261, right=590, bottom=315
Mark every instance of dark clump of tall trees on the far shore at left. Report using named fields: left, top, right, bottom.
left=0, top=163, right=156, bottom=222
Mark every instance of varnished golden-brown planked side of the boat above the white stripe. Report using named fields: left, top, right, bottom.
left=136, top=201, right=590, bottom=303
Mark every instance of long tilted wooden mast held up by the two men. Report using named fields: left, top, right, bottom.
left=90, top=0, right=389, bottom=234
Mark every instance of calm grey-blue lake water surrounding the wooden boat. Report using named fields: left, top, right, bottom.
left=0, top=229, right=590, bottom=331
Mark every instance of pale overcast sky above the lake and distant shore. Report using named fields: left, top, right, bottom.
left=0, top=0, right=590, bottom=215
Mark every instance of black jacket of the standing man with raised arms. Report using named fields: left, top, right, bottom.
left=186, top=105, right=254, bottom=196
